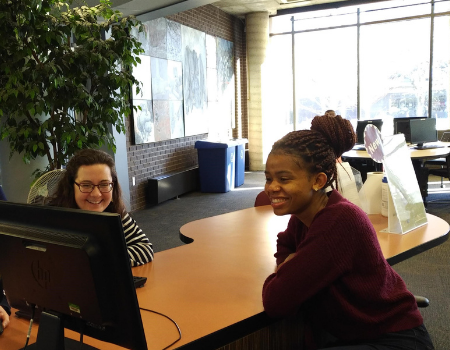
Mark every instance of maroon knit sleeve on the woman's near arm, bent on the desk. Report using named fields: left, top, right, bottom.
left=263, top=191, right=382, bottom=317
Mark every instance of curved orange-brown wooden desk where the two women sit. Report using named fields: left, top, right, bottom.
left=0, top=206, right=449, bottom=350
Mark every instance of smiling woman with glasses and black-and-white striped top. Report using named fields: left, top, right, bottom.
left=49, top=149, right=153, bottom=266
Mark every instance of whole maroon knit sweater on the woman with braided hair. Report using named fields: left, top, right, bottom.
left=262, top=190, right=423, bottom=340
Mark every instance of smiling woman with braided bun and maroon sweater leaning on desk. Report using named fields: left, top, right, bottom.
left=262, top=116, right=434, bottom=350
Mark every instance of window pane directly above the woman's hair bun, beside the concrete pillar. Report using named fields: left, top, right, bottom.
left=295, top=27, right=357, bottom=130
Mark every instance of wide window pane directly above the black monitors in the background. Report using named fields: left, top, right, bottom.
left=360, top=18, right=430, bottom=135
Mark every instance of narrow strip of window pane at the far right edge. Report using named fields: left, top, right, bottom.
left=432, top=16, right=450, bottom=130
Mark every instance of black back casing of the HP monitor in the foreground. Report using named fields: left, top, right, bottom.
left=0, top=201, right=147, bottom=349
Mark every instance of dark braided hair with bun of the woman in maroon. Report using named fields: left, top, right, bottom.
left=271, top=115, right=356, bottom=188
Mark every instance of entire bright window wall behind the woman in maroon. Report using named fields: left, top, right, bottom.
left=270, top=0, right=450, bottom=134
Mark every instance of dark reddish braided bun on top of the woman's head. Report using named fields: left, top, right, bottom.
left=311, top=115, right=356, bottom=158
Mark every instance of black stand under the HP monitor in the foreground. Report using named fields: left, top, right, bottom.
left=22, top=311, right=99, bottom=350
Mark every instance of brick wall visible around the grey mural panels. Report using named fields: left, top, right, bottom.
left=126, top=5, right=248, bottom=211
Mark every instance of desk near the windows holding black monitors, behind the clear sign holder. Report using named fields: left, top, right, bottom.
left=342, top=147, right=450, bottom=200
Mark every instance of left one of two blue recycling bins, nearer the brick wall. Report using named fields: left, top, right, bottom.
left=195, top=140, right=236, bottom=192
